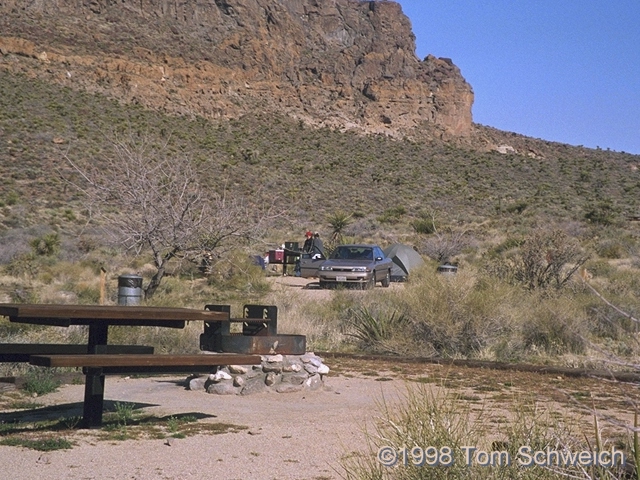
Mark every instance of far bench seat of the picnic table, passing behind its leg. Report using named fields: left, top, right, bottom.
left=0, top=343, right=154, bottom=362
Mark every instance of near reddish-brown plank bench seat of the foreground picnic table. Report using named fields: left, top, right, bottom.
left=29, top=353, right=261, bottom=375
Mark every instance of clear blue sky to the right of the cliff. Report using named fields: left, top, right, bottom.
left=397, top=0, right=640, bottom=154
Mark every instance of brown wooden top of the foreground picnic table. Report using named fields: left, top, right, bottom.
left=0, top=303, right=229, bottom=326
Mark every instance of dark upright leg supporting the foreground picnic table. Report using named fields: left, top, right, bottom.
left=82, top=323, right=109, bottom=428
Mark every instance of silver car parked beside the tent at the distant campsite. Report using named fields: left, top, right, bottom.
left=318, top=244, right=393, bottom=289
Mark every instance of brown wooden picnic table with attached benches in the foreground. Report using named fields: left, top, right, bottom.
left=0, top=304, right=261, bottom=428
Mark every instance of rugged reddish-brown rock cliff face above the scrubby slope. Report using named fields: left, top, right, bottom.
left=0, top=0, right=473, bottom=136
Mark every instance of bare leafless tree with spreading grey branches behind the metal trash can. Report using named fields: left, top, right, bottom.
left=66, top=134, right=275, bottom=298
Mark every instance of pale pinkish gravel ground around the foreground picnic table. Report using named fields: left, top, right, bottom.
left=0, top=377, right=399, bottom=480
